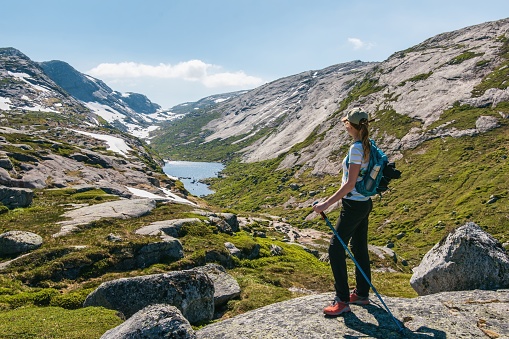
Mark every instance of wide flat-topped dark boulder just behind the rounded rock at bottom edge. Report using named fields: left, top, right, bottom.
left=83, top=270, right=214, bottom=324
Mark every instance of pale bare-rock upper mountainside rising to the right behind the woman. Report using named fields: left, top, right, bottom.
left=156, top=19, right=509, bottom=174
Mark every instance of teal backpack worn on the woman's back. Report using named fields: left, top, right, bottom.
left=346, top=139, right=401, bottom=197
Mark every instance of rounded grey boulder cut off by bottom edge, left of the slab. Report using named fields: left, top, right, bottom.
left=101, top=304, right=196, bottom=339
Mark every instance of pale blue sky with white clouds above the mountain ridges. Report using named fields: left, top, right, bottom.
left=0, top=0, right=509, bottom=108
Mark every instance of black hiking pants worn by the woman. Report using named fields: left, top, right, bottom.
left=329, top=199, right=373, bottom=302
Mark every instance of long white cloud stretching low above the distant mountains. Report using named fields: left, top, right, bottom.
left=88, top=60, right=263, bottom=88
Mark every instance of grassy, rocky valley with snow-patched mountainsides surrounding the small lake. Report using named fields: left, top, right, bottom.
left=0, top=19, right=509, bottom=338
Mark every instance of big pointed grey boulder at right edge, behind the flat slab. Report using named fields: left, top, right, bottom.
left=410, top=222, right=509, bottom=295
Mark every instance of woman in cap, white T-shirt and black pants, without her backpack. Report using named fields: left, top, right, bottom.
left=313, top=108, right=373, bottom=316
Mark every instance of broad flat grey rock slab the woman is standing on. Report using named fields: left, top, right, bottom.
left=196, top=290, right=509, bottom=339
